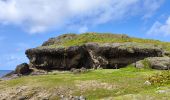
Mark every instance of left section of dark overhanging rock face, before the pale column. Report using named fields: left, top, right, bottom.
left=26, top=46, right=91, bottom=70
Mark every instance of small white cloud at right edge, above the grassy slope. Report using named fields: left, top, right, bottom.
left=147, top=17, right=170, bottom=36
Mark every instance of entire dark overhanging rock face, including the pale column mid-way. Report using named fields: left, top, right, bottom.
left=26, top=43, right=163, bottom=70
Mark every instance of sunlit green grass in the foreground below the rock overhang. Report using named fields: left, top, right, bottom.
left=0, top=65, right=170, bottom=100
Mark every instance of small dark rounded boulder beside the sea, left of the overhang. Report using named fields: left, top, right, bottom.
left=15, top=63, right=32, bottom=75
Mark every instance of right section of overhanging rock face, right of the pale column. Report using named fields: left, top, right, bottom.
left=97, top=43, right=162, bottom=68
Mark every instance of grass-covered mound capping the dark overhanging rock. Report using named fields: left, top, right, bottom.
left=41, top=33, right=170, bottom=51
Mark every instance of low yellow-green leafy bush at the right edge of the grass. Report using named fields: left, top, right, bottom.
left=148, top=71, right=170, bottom=85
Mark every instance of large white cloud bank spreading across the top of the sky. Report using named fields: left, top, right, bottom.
left=0, top=0, right=164, bottom=33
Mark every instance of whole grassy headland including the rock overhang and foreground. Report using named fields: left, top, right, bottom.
left=0, top=33, right=170, bottom=100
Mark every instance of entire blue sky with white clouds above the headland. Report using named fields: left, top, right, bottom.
left=0, top=0, right=170, bottom=70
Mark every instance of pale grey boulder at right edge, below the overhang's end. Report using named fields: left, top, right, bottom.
left=146, top=57, right=170, bottom=70
